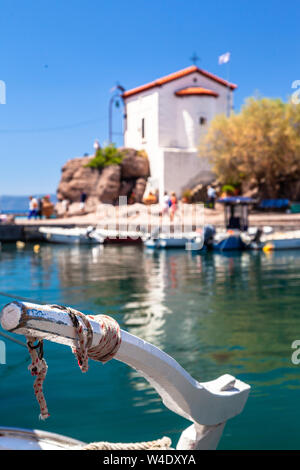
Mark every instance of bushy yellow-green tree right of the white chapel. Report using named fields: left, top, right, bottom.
left=200, top=98, right=300, bottom=197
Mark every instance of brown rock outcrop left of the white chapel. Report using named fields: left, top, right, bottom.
left=57, top=148, right=150, bottom=212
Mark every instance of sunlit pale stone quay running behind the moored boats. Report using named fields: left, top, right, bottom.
left=0, top=204, right=300, bottom=243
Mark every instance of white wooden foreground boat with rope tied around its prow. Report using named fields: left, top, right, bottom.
left=0, top=301, right=250, bottom=450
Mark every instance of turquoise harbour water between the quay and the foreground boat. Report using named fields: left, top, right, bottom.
left=0, top=245, right=300, bottom=449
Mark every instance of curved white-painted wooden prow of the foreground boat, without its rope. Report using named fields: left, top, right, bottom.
left=0, top=302, right=250, bottom=449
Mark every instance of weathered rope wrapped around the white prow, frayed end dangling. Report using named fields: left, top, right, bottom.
left=26, top=305, right=121, bottom=420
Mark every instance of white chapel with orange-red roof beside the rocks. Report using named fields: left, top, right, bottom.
left=123, top=65, right=237, bottom=197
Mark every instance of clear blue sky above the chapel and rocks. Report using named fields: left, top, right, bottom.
left=0, top=0, right=300, bottom=194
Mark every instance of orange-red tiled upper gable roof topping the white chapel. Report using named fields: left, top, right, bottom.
left=122, top=65, right=237, bottom=98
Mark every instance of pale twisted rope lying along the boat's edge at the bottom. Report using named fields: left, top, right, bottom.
left=81, top=436, right=171, bottom=450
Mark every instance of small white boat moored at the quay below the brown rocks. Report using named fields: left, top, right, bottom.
left=39, top=226, right=104, bottom=245
